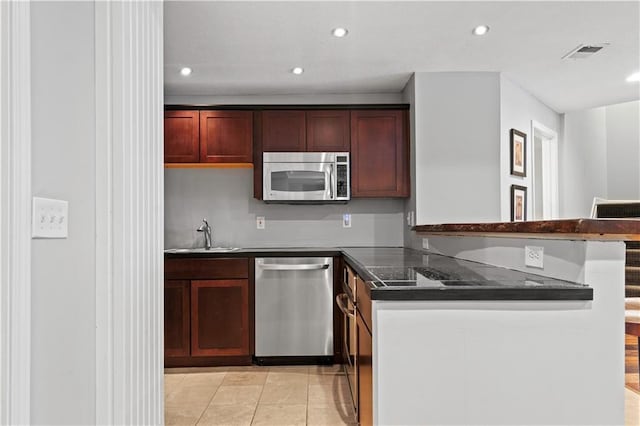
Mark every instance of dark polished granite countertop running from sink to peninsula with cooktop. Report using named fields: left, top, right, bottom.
left=165, top=247, right=593, bottom=300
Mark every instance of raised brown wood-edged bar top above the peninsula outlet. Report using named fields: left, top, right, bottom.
left=412, top=219, right=640, bottom=241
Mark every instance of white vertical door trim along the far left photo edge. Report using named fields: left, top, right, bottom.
left=0, top=0, right=31, bottom=424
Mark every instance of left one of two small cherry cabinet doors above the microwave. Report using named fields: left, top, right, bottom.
left=262, top=110, right=306, bottom=152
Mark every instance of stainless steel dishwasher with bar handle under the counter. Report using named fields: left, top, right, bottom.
left=255, top=257, right=333, bottom=365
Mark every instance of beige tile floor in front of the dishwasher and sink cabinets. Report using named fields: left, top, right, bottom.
left=164, top=366, right=356, bottom=426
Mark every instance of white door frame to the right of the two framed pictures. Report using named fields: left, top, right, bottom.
left=531, top=120, right=560, bottom=220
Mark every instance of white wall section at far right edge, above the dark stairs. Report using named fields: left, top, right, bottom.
left=606, top=101, right=640, bottom=200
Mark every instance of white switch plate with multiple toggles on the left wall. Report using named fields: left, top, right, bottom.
left=31, top=197, right=69, bottom=238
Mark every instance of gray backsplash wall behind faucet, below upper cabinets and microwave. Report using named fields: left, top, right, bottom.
left=164, top=169, right=404, bottom=248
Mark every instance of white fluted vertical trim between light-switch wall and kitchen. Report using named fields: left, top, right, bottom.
left=94, top=2, right=164, bottom=425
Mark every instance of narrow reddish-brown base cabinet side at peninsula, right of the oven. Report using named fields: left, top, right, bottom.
left=356, top=277, right=373, bottom=426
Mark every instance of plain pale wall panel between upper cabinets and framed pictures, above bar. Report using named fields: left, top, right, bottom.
left=413, top=72, right=500, bottom=224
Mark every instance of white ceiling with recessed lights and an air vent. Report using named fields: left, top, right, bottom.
left=164, top=1, right=640, bottom=112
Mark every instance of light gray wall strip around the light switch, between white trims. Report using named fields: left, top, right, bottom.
left=31, top=2, right=96, bottom=424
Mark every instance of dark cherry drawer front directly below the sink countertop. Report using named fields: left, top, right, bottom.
left=164, top=258, right=249, bottom=280
